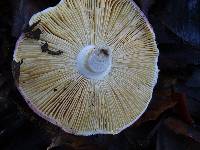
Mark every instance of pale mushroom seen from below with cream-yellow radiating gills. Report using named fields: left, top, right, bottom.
left=14, top=0, right=159, bottom=135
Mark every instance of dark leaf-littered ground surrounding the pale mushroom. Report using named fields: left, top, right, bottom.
left=0, top=0, right=200, bottom=150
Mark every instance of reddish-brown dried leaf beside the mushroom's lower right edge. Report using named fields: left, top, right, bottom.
left=135, top=89, right=193, bottom=126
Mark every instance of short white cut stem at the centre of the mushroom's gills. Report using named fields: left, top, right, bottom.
left=77, top=45, right=112, bottom=80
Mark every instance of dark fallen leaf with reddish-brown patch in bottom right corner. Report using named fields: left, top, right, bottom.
left=156, top=118, right=200, bottom=150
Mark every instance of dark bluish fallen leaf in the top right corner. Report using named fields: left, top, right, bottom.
left=153, top=0, right=200, bottom=48
